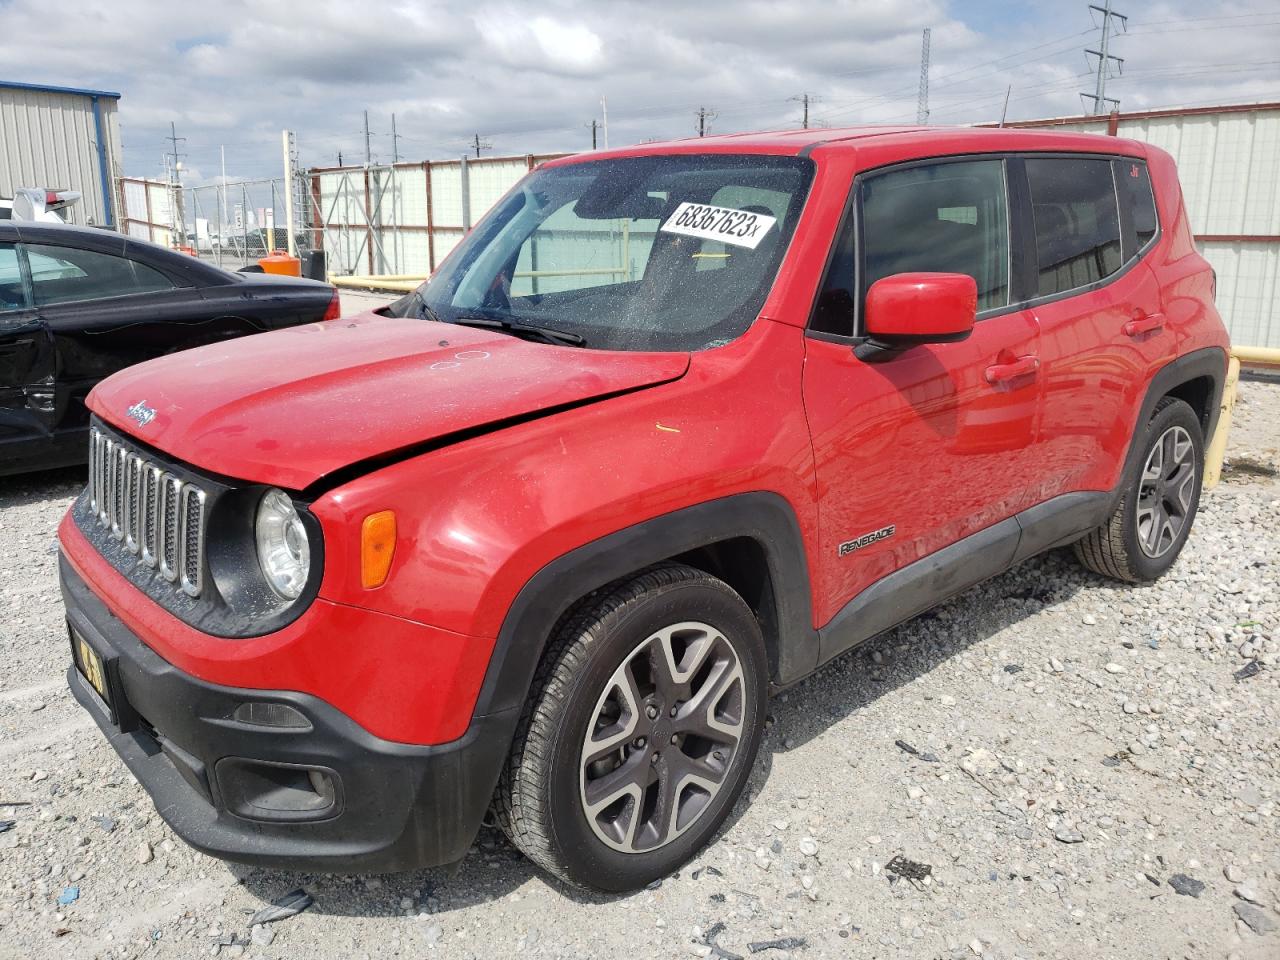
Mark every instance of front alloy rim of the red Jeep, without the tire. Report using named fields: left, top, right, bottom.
left=579, top=622, right=746, bottom=854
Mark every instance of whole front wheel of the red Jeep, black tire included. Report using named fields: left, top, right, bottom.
left=494, top=564, right=768, bottom=892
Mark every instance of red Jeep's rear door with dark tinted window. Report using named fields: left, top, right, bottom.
left=1025, top=156, right=1178, bottom=499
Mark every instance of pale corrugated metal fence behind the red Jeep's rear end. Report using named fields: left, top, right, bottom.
left=1006, top=104, right=1280, bottom=347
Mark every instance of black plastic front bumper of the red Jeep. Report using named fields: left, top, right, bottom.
left=60, top=558, right=516, bottom=873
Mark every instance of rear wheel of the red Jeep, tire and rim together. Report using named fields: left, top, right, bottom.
left=1075, top=397, right=1204, bottom=584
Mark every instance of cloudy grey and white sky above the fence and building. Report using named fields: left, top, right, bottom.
left=0, top=0, right=1280, bottom=184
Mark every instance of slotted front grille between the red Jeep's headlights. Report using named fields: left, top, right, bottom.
left=88, top=426, right=207, bottom=596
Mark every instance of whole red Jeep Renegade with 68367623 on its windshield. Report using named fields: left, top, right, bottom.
left=60, top=128, right=1228, bottom=890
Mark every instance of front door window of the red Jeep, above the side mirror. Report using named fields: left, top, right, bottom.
left=861, top=160, right=1009, bottom=310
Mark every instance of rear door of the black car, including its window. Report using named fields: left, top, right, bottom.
left=23, top=237, right=222, bottom=429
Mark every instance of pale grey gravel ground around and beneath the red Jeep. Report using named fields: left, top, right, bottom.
left=0, top=383, right=1280, bottom=960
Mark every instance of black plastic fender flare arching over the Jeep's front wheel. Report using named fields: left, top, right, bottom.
left=474, top=492, right=818, bottom=718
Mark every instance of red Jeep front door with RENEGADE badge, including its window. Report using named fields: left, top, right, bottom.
left=804, top=157, right=1039, bottom=632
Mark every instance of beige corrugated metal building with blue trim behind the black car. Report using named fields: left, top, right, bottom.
left=0, top=81, right=120, bottom=227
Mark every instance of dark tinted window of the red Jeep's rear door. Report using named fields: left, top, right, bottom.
left=1027, top=157, right=1123, bottom=297
